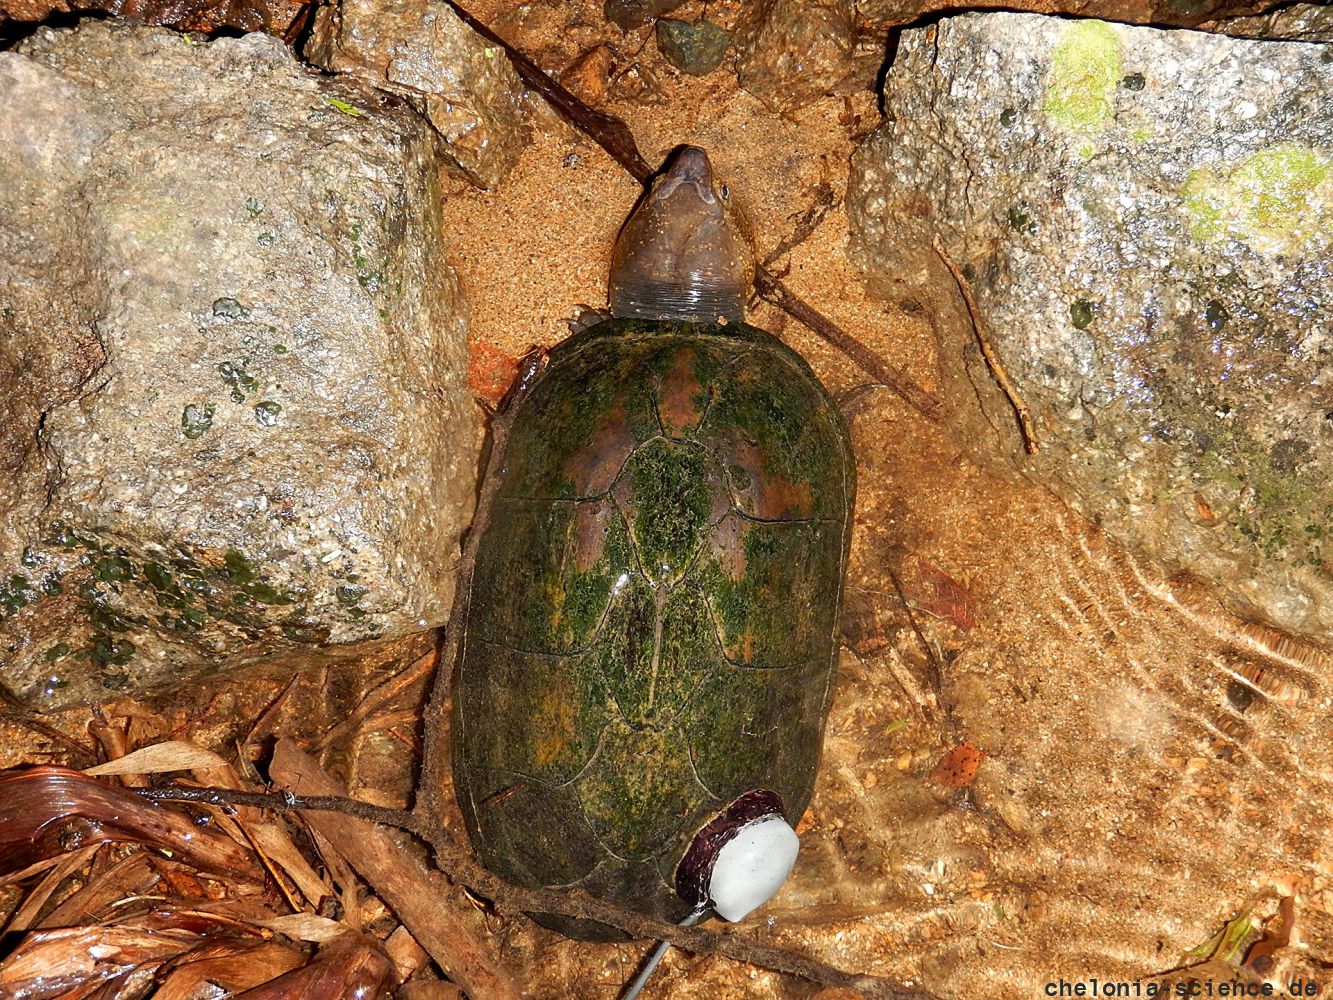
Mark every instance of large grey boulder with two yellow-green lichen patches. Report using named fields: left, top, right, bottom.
left=848, top=15, right=1333, bottom=643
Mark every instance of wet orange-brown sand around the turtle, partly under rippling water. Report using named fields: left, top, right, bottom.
left=5, top=0, right=1333, bottom=1000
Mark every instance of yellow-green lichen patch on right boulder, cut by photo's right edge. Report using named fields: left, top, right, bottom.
left=1180, top=143, right=1333, bottom=256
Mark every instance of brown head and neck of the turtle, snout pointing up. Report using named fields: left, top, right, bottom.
left=611, top=145, right=754, bottom=323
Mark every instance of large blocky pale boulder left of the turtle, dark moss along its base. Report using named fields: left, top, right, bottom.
left=0, top=21, right=476, bottom=704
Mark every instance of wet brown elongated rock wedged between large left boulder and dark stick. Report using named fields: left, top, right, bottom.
left=305, top=0, right=528, bottom=188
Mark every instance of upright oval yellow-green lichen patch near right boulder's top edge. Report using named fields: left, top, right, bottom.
left=1042, top=20, right=1124, bottom=132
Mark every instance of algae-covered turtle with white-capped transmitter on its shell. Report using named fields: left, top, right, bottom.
left=451, top=147, right=856, bottom=940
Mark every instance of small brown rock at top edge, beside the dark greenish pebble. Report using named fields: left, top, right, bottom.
left=734, top=0, right=858, bottom=113
